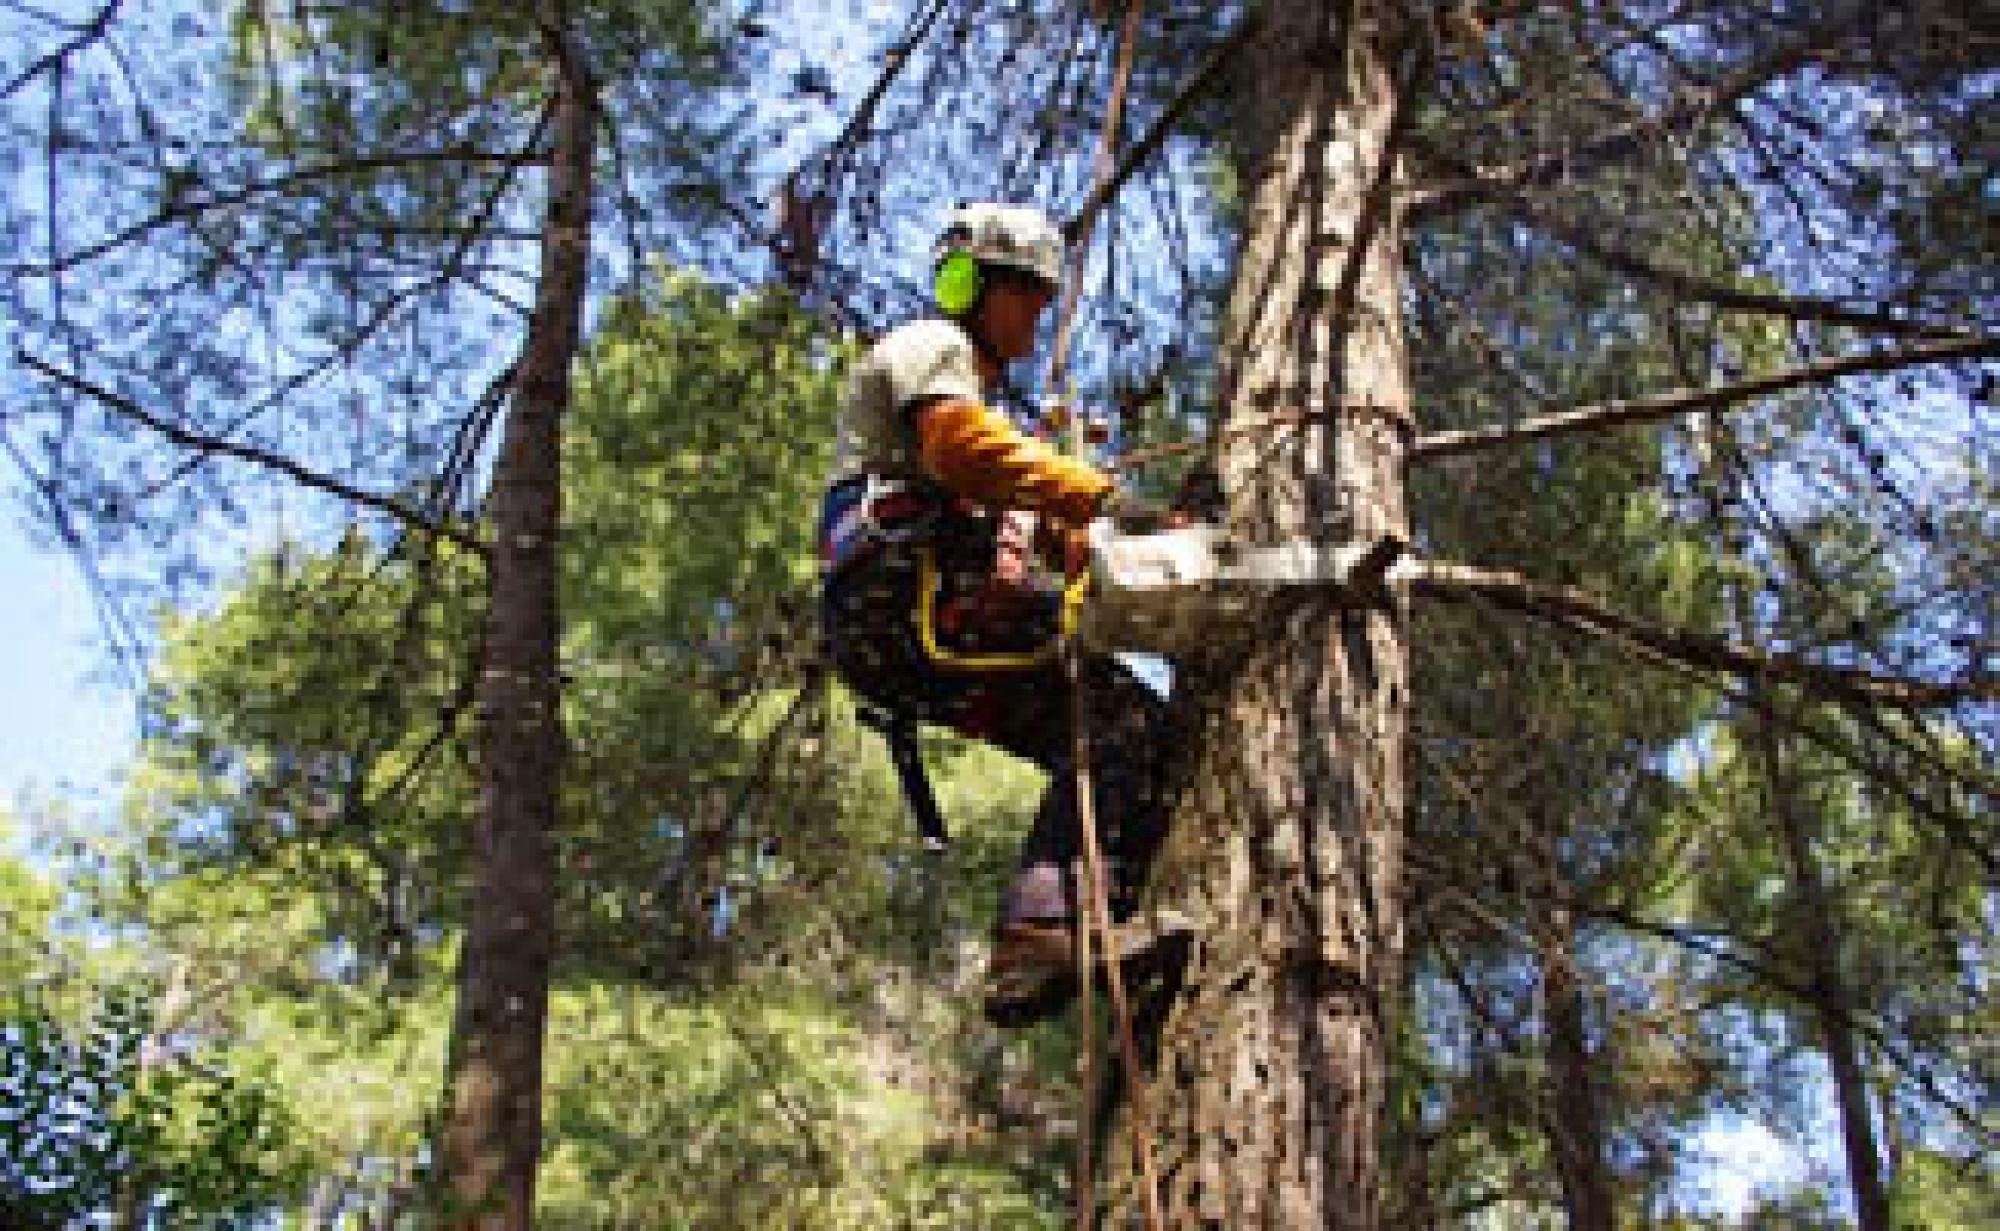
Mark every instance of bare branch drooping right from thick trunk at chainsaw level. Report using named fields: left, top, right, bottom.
left=1410, top=562, right=2000, bottom=709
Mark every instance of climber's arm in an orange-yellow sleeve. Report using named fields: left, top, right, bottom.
left=910, top=398, right=1114, bottom=526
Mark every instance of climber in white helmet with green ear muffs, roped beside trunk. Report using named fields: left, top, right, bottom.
left=818, top=204, right=1168, bottom=1025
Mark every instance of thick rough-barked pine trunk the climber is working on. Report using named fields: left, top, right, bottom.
left=1106, top=0, right=1410, bottom=1231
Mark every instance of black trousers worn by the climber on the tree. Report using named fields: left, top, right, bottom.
left=822, top=536, right=1166, bottom=923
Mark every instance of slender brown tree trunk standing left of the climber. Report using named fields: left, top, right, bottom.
left=440, top=24, right=596, bottom=1231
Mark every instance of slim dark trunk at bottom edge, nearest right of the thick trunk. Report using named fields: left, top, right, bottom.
left=1536, top=895, right=1618, bottom=1231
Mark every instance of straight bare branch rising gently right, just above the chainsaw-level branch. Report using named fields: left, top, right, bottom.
left=1410, top=336, right=2000, bottom=462
